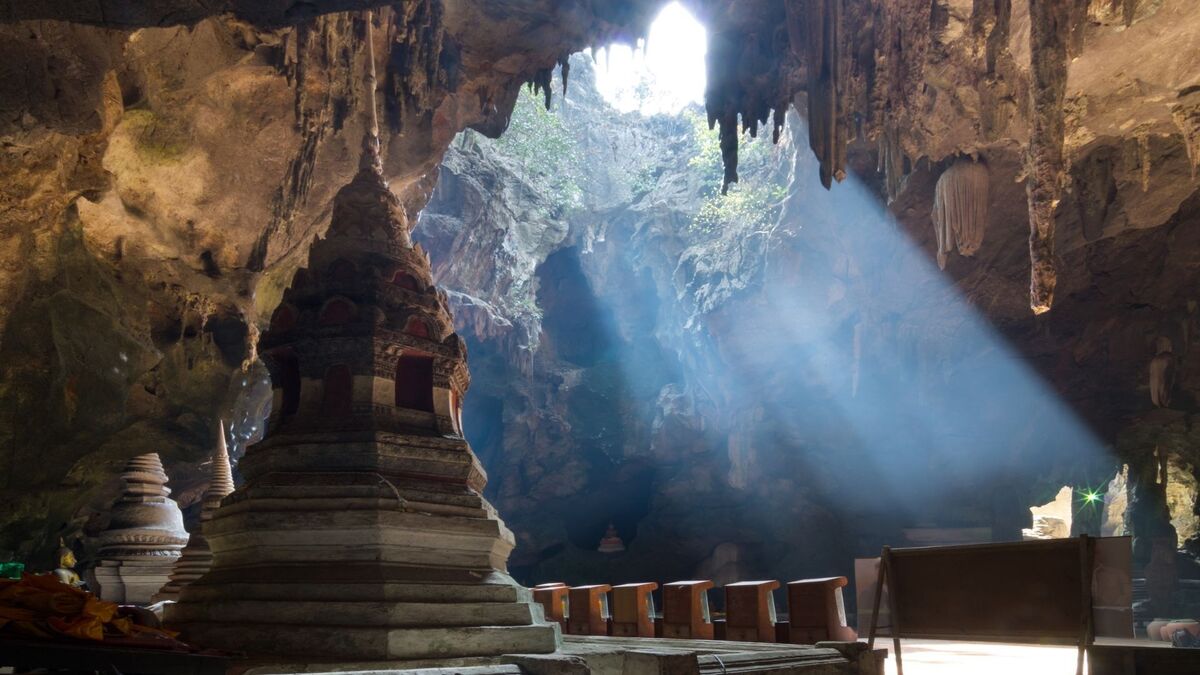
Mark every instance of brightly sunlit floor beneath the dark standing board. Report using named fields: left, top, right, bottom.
left=875, top=640, right=1169, bottom=675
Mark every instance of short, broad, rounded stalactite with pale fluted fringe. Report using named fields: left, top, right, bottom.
left=932, top=157, right=989, bottom=269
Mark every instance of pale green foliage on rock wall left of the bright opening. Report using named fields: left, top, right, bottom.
left=497, top=89, right=583, bottom=216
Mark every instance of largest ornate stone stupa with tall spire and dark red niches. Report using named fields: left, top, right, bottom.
left=166, top=14, right=558, bottom=663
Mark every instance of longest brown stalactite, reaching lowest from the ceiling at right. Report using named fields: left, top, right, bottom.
left=1026, top=0, right=1070, bottom=313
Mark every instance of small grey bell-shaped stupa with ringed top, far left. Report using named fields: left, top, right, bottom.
left=90, top=453, right=187, bottom=604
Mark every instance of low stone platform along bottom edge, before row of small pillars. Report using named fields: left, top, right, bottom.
left=239, top=635, right=887, bottom=675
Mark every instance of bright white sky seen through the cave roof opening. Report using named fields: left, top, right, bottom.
left=595, top=2, right=708, bottom=115
